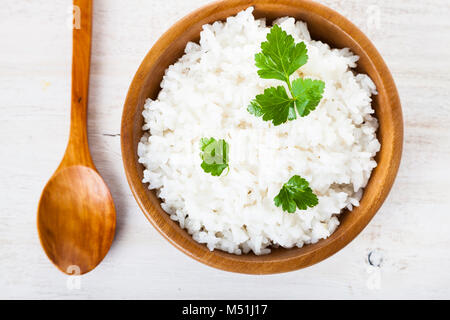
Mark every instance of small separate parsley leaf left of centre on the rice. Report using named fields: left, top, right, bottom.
left=200, top=138, right=229, bottom=176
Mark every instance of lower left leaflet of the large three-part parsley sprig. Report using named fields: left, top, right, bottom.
left=247, top=86, right=297, bottom=126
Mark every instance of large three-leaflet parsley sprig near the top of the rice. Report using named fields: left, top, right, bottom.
left=247, top=25, right=325, bottom=126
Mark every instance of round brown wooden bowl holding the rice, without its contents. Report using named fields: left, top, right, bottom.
left=121, top=0, right=403, bottom=274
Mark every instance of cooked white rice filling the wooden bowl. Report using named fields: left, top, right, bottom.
left=138, top=8, right=380, bottom=255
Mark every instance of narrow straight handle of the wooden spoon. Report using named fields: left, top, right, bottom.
left=63, top=0, right=93, bottom=166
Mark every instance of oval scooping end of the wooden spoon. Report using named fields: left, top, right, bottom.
left=38, top=165, right=115, bottom=274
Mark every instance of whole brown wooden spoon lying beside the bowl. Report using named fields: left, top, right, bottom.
left=37, top=0, right=116, bottom=274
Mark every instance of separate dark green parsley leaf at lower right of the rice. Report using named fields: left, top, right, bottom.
left=273, top=175, right=319, bottom=213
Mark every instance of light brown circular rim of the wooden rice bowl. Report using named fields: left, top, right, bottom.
left=120, top=0, right=403, bottom=274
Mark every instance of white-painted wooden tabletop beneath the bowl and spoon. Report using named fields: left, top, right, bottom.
left=0, top=0, right=450, bottom=299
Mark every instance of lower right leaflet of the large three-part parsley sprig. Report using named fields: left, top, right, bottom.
left=292, top=78, right=325, bottom=117
